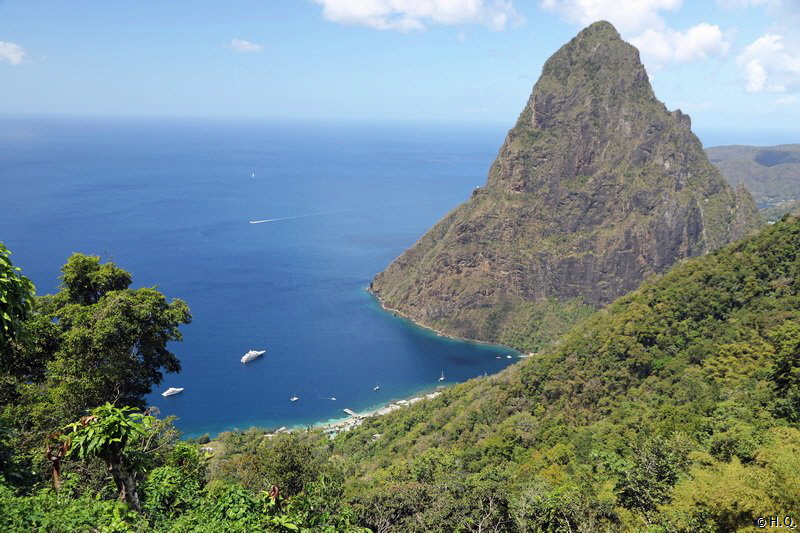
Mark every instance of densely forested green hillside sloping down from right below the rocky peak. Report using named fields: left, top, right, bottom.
left=336, top=214, right=800, bottom=531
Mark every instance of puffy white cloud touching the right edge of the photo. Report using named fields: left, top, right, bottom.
left=736, top=33, right=800, bottom=93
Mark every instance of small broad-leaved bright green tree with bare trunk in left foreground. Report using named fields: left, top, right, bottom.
left=66, top=403, right=154, bottom=511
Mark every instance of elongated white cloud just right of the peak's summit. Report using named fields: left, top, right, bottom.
left=630, top=22, right=731, bottom=66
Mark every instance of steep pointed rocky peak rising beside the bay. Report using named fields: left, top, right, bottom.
left=371, top=22, right=761, bottom=349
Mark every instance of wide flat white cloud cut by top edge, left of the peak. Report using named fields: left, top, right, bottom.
left=314, top=0, right=522, bottom=31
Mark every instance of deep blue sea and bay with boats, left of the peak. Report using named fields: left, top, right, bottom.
left=0, top=118, right=516, bottom=435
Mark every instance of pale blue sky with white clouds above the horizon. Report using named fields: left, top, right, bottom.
left=0, top=0, right=800, bottom=144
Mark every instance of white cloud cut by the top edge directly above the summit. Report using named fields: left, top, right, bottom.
left=539, top=0, right=681, bottom=34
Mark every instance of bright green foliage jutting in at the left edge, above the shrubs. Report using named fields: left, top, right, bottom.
left=0, top=242, right=35, bottom=352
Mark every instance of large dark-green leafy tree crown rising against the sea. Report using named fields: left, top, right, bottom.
left=27, top=254, right=191, bottom=416
